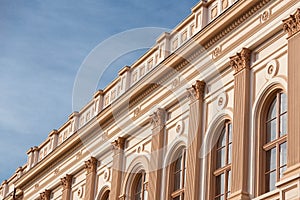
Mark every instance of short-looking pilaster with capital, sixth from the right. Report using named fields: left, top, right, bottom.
left=84, top=157, right=98, bottom=200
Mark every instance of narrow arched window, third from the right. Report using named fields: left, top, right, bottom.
left=171, top=149, right=186, bottom=200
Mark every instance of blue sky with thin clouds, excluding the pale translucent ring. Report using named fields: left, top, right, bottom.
left=0, top=0, right=198, bottom=181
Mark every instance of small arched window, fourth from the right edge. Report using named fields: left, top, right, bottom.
left=132, top=171, right=148, bottom=200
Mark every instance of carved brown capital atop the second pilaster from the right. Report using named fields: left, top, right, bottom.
left=230, top=48, right=251, bottom=73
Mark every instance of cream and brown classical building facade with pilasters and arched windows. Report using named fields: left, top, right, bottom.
left=0, top=0, right=300, bottom=200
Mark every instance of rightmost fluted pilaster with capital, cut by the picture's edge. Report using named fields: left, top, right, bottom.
left=283, top=8, right=300, bottom=174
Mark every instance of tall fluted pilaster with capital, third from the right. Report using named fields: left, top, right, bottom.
left=184, top=80, right=205, bottom=200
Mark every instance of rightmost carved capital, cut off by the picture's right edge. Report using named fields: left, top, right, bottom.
left=282, top=8, right=300, bottom=37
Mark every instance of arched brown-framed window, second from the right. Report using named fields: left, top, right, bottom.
left=213, top=121, right=232, bottom=200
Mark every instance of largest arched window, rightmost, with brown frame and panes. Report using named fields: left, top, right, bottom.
left=263, top=92, right=287, bottom=192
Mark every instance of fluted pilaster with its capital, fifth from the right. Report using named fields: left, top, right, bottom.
left=109, top=137, right=125, bottom=200
